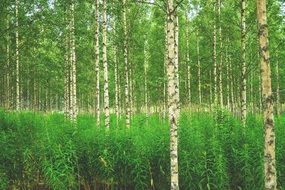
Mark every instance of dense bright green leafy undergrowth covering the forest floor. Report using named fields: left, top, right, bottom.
left=0, top=111, right=285, bottom=190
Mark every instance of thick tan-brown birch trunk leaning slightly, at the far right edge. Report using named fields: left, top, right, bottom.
left=257, top=0, right=277, bottom=190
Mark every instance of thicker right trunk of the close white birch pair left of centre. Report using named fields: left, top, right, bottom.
left=102, top=0, right=110, bottom=128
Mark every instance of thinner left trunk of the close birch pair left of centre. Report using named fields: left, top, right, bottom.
left=95, top=0, right=100, bottom=127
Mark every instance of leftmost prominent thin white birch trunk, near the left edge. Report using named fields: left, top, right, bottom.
left=15, top=0, right=21, bottom=111
